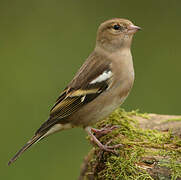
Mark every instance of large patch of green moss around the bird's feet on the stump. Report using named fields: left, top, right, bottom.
left=89, top=109, right=181, bottom=180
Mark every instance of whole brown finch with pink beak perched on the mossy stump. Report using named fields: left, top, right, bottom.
left=8, top=18, right=141, bottom=165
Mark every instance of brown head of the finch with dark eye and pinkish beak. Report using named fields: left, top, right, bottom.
left=96, top=18, right=141, bottom=51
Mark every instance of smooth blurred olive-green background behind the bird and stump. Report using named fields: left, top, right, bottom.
left=0, top=0, right=181, bottom=180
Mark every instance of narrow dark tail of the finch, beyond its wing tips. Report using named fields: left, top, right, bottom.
left=8, top=133, right=44, bottom=165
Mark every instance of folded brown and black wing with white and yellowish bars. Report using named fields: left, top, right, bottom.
left=36, top=53, right=112, bottom=133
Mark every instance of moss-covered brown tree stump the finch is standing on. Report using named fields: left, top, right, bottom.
left=79, top=109, right=181, bottom=180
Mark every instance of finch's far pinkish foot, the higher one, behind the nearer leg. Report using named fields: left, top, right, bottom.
left=91, top=125, right=119, bottom=138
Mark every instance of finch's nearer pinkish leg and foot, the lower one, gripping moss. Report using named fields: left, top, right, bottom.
left=85, top=127, right=122, bottom=154
